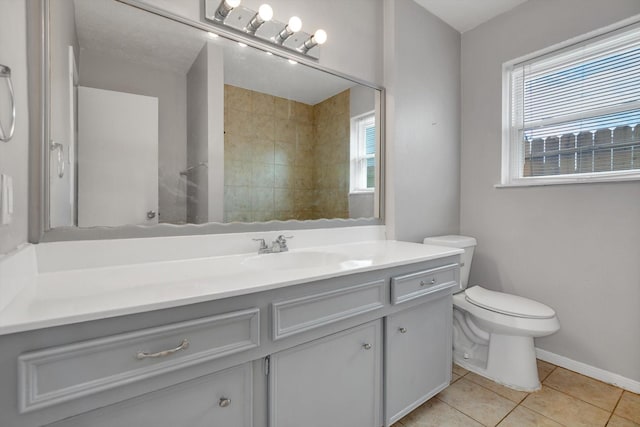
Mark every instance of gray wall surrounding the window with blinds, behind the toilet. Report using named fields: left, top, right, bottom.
left=460, top=0, right=640, bottom=381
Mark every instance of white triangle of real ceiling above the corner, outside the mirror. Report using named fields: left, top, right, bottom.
left=415, top=0, right=527, bottom=33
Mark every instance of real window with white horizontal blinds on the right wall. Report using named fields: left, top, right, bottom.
left=502, top=25, right=640, bottom=185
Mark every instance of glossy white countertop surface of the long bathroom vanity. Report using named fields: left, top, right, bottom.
left=0, top=240, right=463, bottom=335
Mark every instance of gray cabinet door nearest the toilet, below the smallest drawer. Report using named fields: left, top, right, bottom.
left=385, top=294, right=453, bottom=425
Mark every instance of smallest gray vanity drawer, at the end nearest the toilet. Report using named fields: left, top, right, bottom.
left=391, top=264, right=459, bottom=304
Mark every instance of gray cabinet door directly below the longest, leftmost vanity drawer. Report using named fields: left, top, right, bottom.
left=50, top=363, right=253, bottom=427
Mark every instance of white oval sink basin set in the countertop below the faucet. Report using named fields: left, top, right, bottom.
left=242, top=251, right=349, bottom=270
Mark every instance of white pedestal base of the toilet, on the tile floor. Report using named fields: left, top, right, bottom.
left=453, top=333, right=540, bottom=392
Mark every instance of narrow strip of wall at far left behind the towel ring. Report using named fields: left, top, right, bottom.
left=0, top=0, right=29, bottom=255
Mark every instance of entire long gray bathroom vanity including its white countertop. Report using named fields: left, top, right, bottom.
left=0, top=241, right=460, bottom=427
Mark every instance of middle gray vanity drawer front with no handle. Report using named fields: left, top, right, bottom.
left=272, top=280, right=385, bottom=340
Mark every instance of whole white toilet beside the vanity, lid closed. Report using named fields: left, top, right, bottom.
left=424, top=236, right=560, bottom=391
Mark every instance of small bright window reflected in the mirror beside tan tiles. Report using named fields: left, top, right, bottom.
left=350, top=111, right=376, bottom=193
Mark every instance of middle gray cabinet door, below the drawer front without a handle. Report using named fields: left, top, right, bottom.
left=269, top=320, right=382, bottom=427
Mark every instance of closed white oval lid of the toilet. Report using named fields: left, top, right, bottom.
left=465, top=286, right=556, bottom=319
